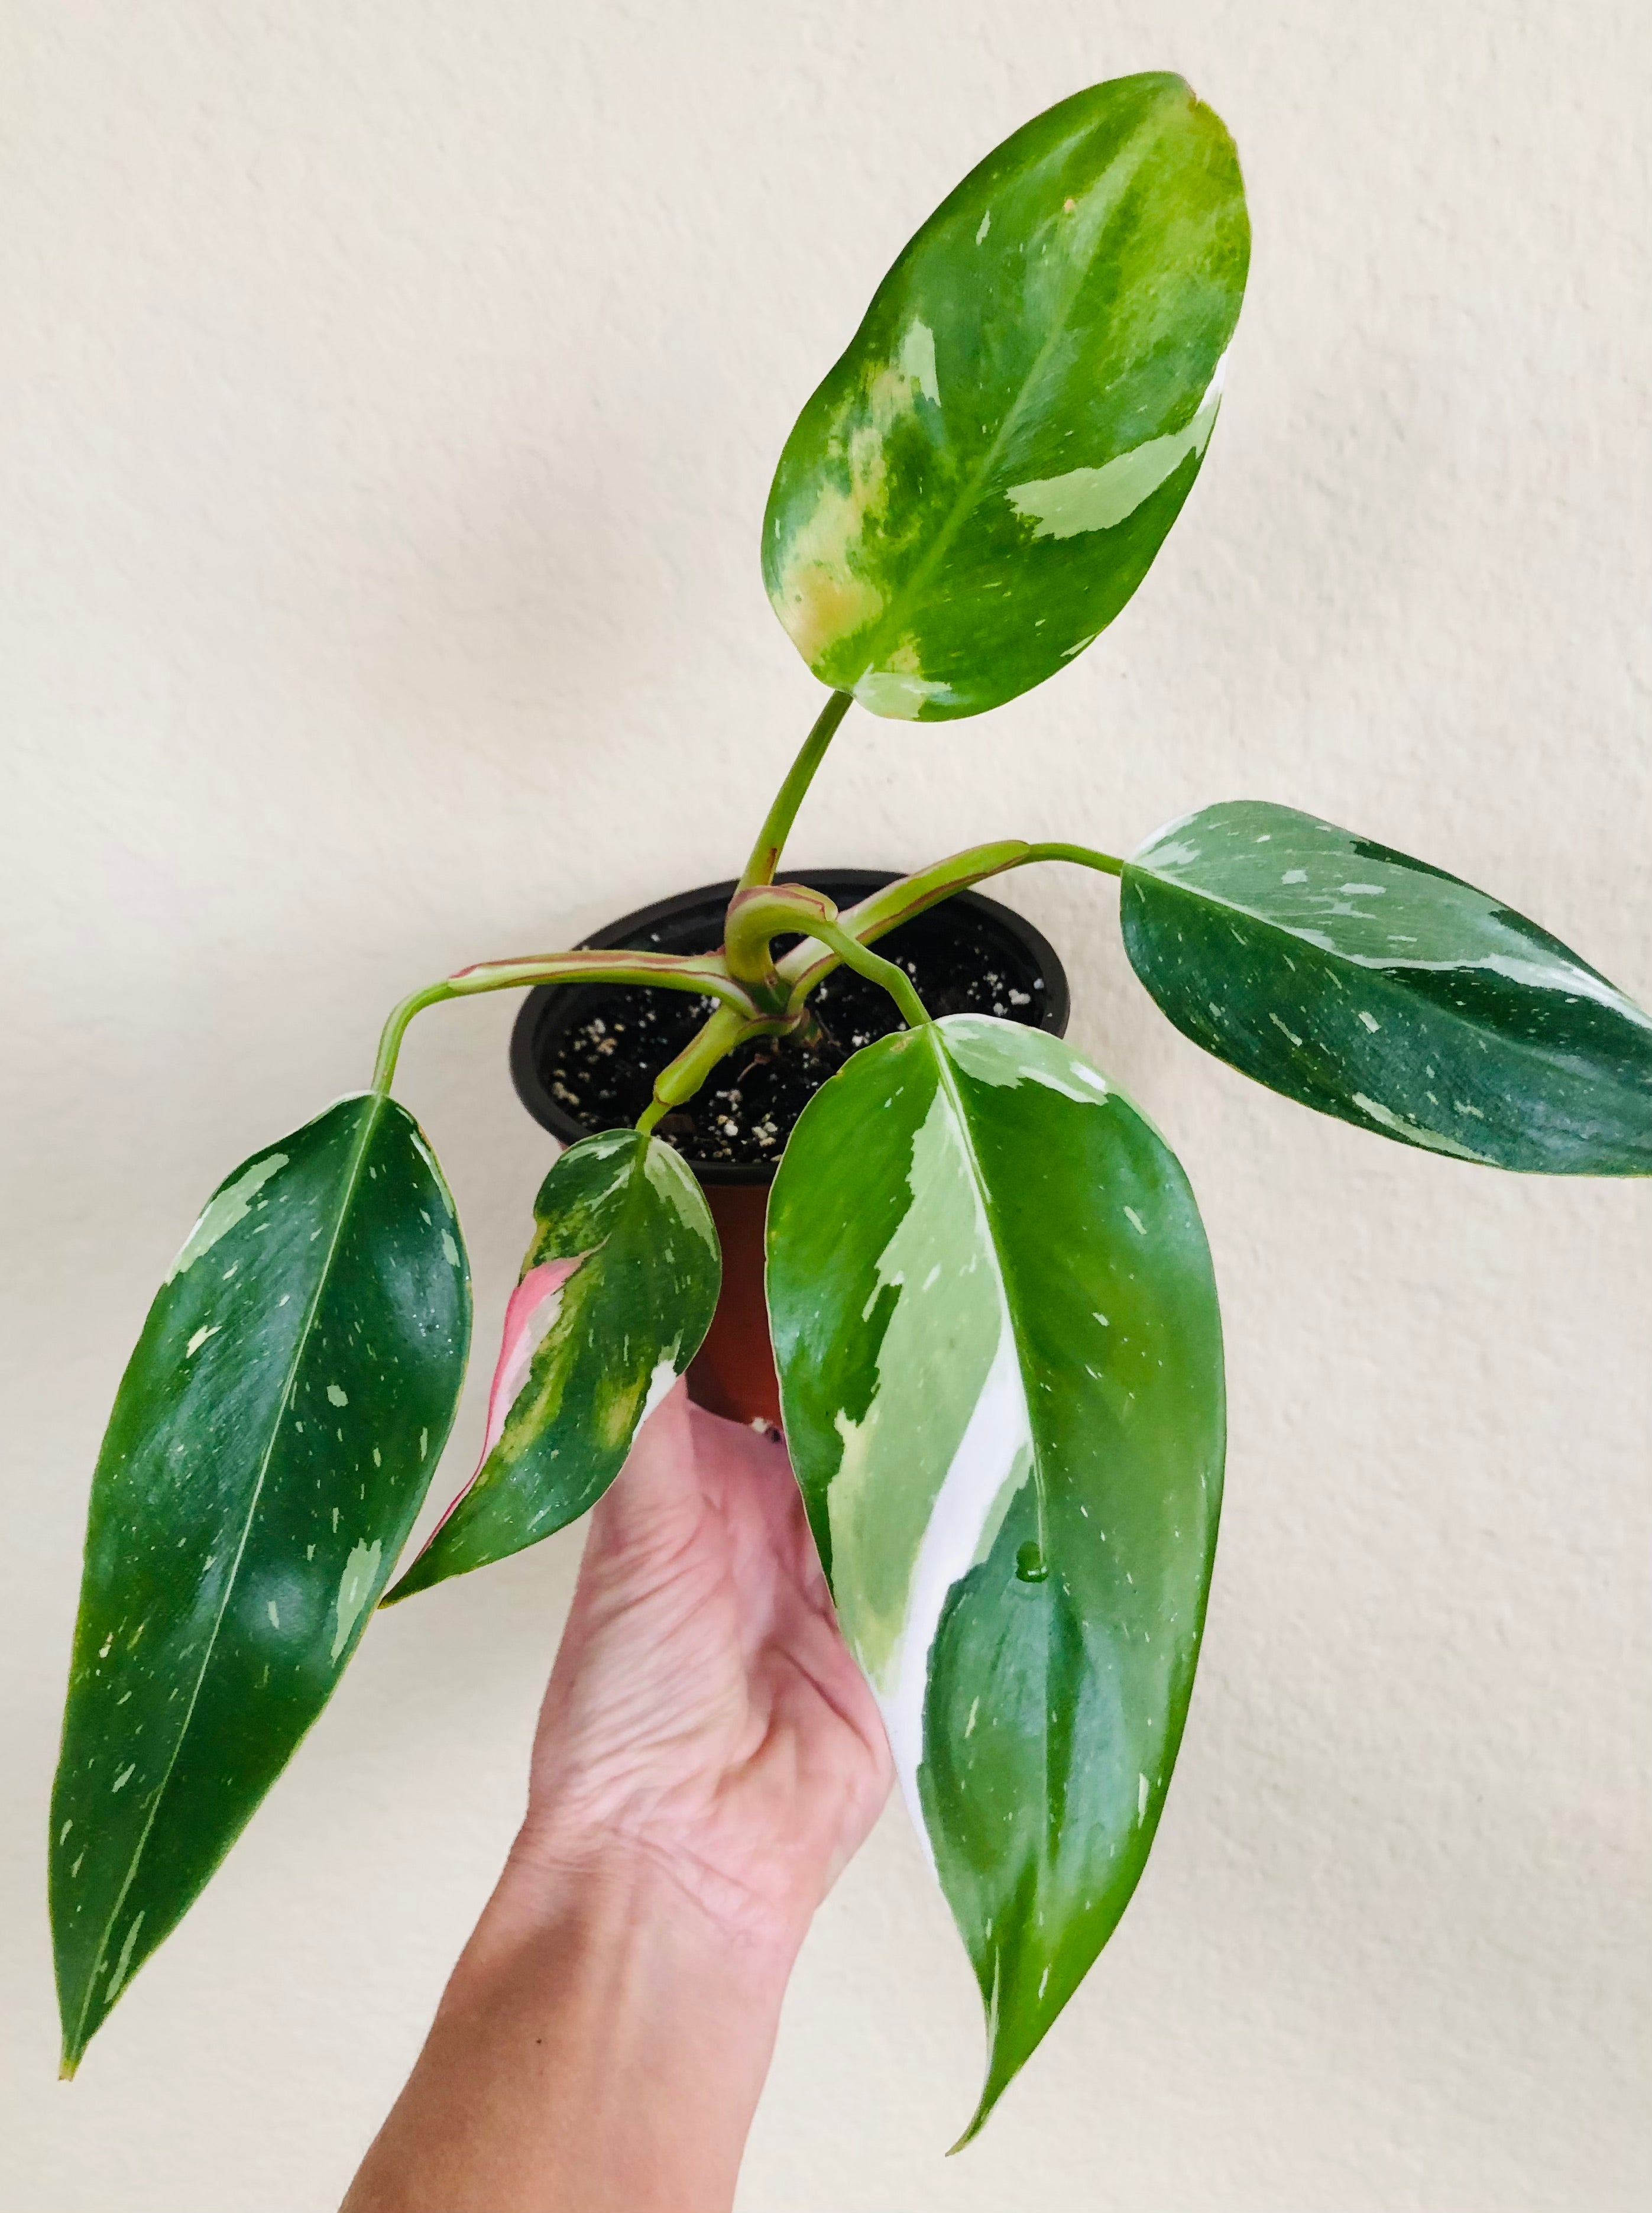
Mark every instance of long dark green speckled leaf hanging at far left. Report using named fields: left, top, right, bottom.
left=51, top=1093, right=471, bottom=2072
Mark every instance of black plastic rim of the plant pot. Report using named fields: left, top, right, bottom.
left=511, top=868, right=1073, bottom=1186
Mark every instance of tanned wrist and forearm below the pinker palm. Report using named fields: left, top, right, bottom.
left=347, top=1835, right=796, bottom=2213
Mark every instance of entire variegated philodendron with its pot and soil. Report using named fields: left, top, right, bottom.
left=51, top=75, right=1652, bottom=2131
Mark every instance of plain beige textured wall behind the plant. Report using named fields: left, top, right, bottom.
left=0, top=0, right=1652, bottom=2213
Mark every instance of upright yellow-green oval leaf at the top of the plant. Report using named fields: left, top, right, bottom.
left=763, top=75, right=1249, bottom=722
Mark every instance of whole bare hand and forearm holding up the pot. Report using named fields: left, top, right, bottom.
left=345, top=1385, right=891, bottom=2213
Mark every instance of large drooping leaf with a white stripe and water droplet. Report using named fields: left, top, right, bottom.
left=767, top=1016, right=1223, bottom=2133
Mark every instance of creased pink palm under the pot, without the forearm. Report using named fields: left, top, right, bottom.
left=529, top=1385, right=891, bottom=1932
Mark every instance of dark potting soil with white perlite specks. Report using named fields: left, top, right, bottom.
left=540, top=905, right=1061, bottom=1164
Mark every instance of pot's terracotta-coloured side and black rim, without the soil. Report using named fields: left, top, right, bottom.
left=511, top=868, right=1068, bottom=1428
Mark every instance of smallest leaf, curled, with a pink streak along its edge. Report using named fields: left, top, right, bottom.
left=385, top=1128, right=723, bottom=1604
